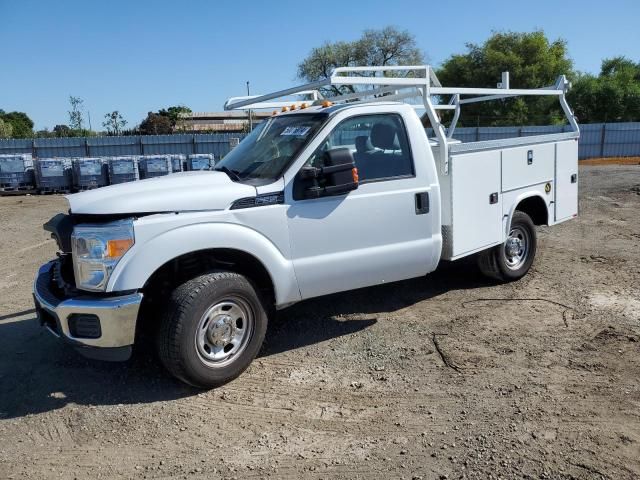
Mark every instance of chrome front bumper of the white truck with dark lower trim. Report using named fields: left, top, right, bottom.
left=33, top=261, right=142, bottom=361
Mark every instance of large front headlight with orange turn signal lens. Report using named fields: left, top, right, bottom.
left=71, top=219, right=134, bottom=292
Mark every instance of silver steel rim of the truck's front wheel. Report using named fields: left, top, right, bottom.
left=195, top=297, right=254, bottom=367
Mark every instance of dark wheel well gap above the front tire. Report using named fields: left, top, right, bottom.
left=138, top=248, right=275, bottom=332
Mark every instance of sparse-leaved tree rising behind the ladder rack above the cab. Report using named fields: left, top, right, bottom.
left=298, top=26, right=425, bottom=95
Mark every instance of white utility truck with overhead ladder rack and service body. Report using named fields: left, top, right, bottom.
left=34, top=66, right=579, bottom=388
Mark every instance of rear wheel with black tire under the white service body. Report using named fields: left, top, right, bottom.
left=478, top=211, right=537, bottom=282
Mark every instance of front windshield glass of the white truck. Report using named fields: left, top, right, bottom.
left=215, top=113, right=327, bottom=180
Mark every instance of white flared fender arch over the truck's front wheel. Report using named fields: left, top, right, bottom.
left=107, top=222, right=300, bottom=305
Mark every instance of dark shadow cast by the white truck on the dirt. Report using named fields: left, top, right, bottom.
left=0, top=256, right=488, bottom=419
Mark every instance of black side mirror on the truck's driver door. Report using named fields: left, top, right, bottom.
left=300, top=148, right=358, bottom=198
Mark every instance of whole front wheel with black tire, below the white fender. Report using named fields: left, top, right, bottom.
left=157, top=271, right=268, bottom=388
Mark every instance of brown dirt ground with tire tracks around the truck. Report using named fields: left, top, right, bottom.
left=0, top=166, right=640, bottom=479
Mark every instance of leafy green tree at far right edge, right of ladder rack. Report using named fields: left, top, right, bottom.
left=568, top=57, right=640, bottom=123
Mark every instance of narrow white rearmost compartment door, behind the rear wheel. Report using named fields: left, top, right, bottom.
left=554, top=139, right=578, bottom=223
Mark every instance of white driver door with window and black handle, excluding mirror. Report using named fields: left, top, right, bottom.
left=285, top=113, right=434, bottom=298
